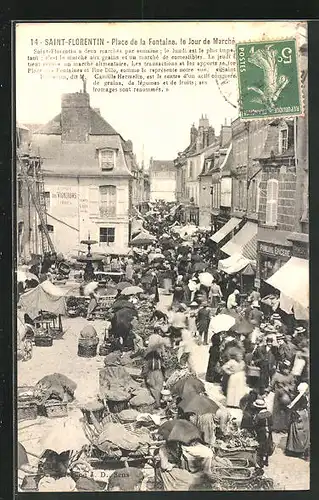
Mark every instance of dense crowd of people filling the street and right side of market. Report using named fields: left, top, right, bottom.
left=17, top=204, right=310, bottom=490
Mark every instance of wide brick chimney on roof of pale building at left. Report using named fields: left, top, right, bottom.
left=61, top=92, right=90, bottom=142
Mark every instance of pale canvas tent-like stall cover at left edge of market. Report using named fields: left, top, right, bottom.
left=19, top=281, right=67, bottom=319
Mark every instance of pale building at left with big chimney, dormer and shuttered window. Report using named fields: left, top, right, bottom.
left=26, top=86, right=136, bottom=254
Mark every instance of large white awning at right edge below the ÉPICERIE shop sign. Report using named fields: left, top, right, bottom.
left=266, top=257, right=309, bottom=309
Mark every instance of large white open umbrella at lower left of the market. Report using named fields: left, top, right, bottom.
left=41, top=418, right=90, bottom=455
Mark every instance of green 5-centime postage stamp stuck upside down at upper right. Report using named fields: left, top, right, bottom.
left=236, top=40, right=302, bottom=119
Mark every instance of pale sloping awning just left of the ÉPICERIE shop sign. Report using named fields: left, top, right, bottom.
left=221, top=222, right=258, bottom=260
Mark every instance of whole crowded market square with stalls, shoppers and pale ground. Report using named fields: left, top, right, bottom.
left=17, top=200, right=309, bottom=491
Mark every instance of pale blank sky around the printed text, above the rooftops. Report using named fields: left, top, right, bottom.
left=16, top=22, right=303, bottom=165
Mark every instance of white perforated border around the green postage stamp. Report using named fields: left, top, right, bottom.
left=235, top=32, right=308, bottom=122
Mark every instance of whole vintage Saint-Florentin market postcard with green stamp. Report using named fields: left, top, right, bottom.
left=13, top=21, right=310, bottom=492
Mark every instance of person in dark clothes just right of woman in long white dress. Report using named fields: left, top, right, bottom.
left=253, top=336, right=278, bottom=394
